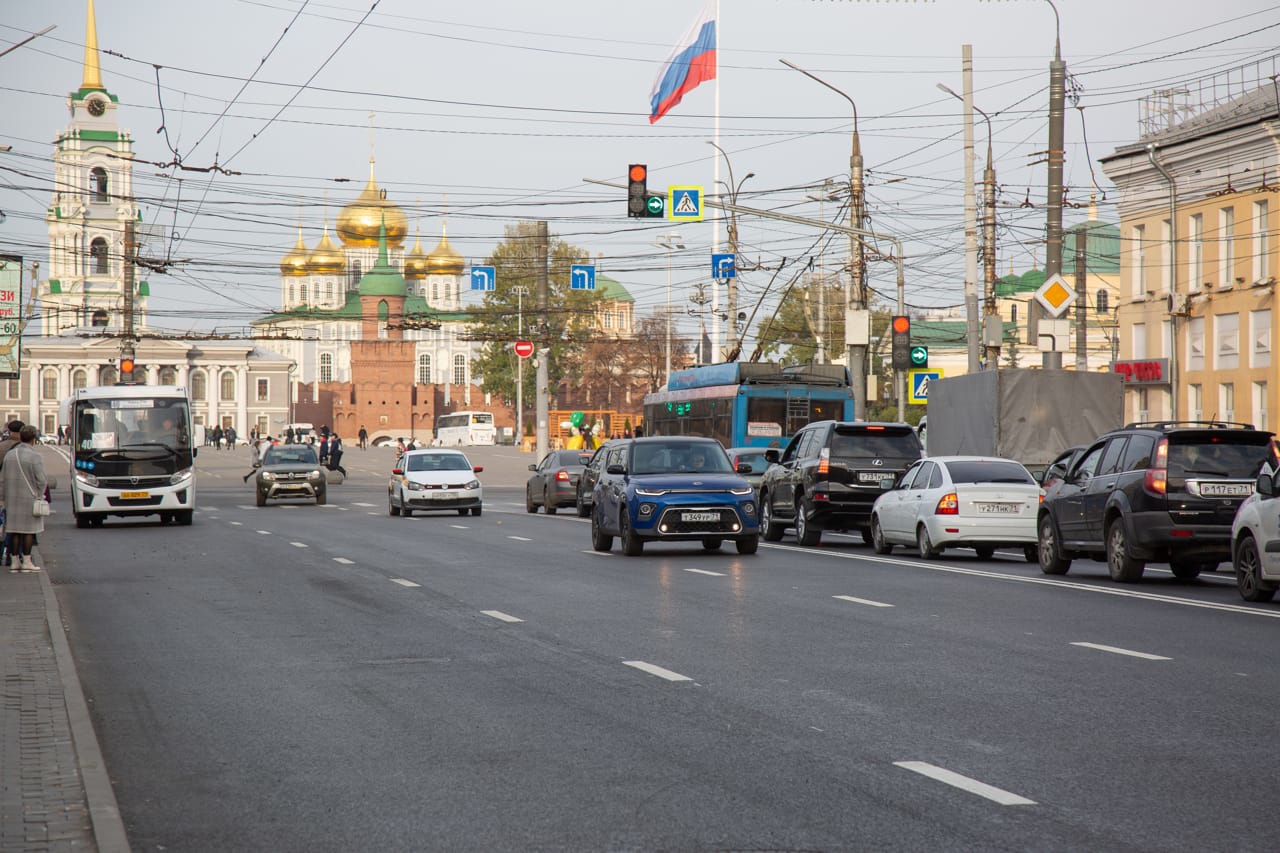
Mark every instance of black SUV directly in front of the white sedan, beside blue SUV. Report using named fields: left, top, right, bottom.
left=760, top=420, right=923, bottom=546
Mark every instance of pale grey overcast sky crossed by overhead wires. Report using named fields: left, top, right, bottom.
left=0, top=0, right=1280, bottom=345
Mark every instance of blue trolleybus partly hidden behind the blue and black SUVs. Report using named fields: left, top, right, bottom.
left=644, top=362, right=854, bottom=447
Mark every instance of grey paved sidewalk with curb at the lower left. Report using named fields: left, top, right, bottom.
left=0, top=548, right=129, bottom=853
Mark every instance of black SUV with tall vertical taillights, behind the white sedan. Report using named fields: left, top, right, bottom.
left=1037, top=421, right=1272, bottom=583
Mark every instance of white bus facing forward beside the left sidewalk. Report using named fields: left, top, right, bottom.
left=61, top=386, right=196, bottom=528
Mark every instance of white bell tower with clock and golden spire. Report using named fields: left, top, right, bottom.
left=40, top=0, right=150, bottom=336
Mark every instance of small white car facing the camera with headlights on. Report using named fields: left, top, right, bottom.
left=387, top=448, right=484, bottom=517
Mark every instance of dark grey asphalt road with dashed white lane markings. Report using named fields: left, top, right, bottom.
left=42, top=440, right=1280, bottom=850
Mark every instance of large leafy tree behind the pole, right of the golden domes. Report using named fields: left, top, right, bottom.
left=468, top=222, right=599, bottom=406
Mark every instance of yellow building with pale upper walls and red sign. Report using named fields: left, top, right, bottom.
left=1102, top=82, right=1280, bottom=428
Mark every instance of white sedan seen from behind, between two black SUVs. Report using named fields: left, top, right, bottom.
left=872, top=456, right=1044, bottom=562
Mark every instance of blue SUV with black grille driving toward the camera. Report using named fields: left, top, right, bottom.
left=591, top=437, right=760, bottom=557
